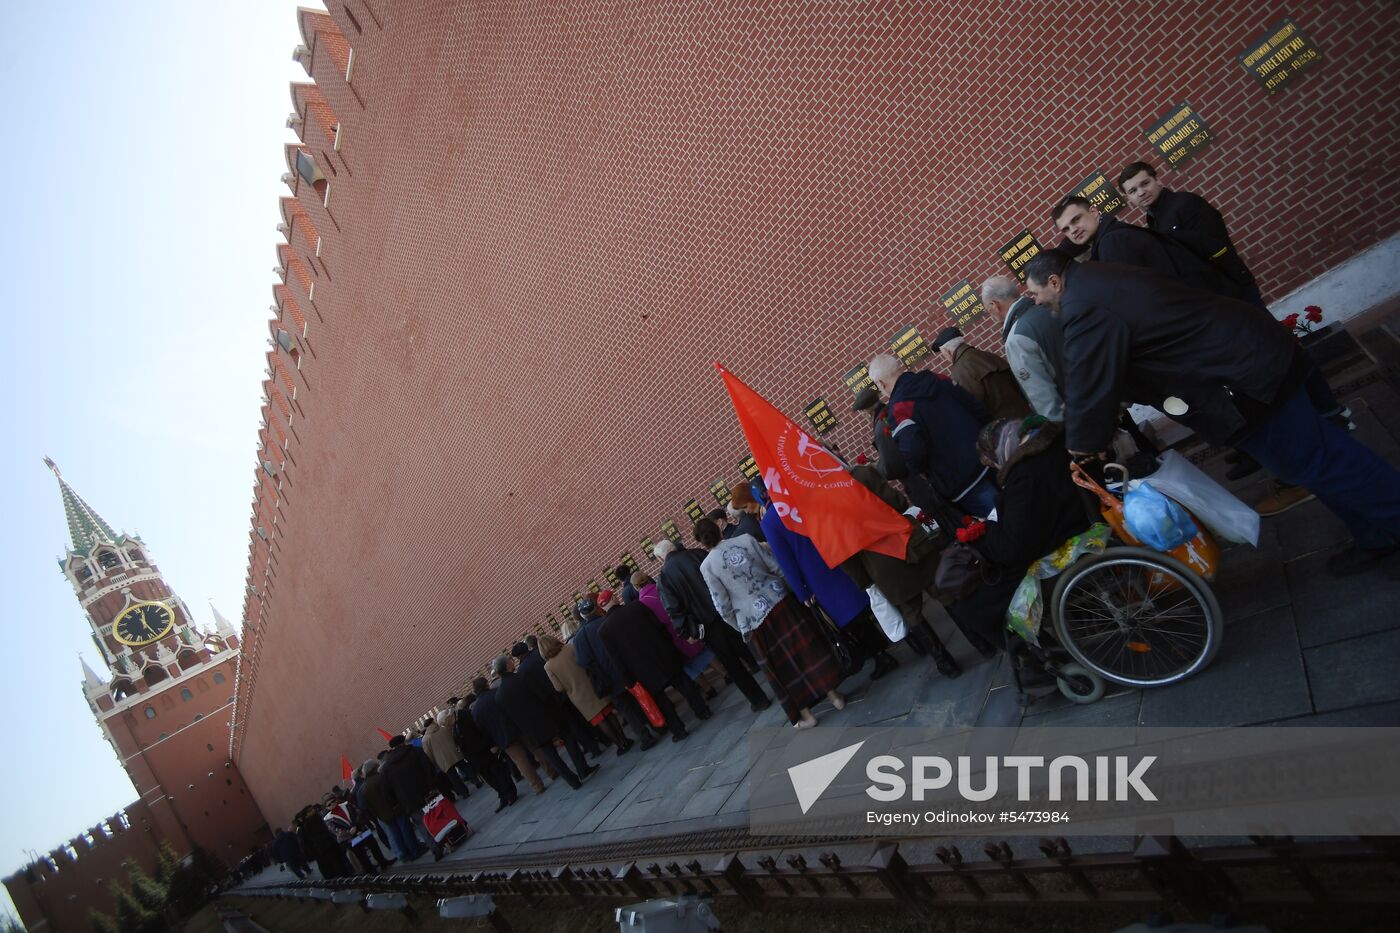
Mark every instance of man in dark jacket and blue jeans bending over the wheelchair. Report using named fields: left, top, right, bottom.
left=1026, top=249, right=1400, bottom=574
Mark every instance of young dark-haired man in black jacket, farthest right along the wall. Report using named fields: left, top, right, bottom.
left=1119, top=163, right=1266, bottom=308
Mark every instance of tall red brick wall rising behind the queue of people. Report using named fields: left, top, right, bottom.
left=238, top=0, right=1400, bottom=820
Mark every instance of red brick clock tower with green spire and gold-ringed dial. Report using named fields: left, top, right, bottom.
left=45, top=459, right=269, bottom=866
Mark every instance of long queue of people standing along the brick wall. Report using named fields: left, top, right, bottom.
left=246, top=163, right=1400, bottom=877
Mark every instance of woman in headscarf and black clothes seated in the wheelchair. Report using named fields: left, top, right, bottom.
left=948, top=415, right=1095, bottom=643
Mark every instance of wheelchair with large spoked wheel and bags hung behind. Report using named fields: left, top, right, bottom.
left=1005, top=464, right=1224, bottom=707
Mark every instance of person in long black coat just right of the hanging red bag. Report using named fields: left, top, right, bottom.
left=598, top=590, right=711, bottom=742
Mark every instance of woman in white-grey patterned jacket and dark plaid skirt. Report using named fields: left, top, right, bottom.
left=694, top=518, right=846, bottom=728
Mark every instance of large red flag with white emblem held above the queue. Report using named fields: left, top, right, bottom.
left=714, top=363, right=913, bottom=567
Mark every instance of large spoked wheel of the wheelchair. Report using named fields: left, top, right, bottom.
left=1050, top=548, right=1224, bottom=686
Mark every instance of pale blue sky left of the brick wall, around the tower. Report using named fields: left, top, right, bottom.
left=0, top=0, right=320, bottom=907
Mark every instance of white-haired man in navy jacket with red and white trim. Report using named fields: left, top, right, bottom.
left=869, top=353, right=997, bottom=518
